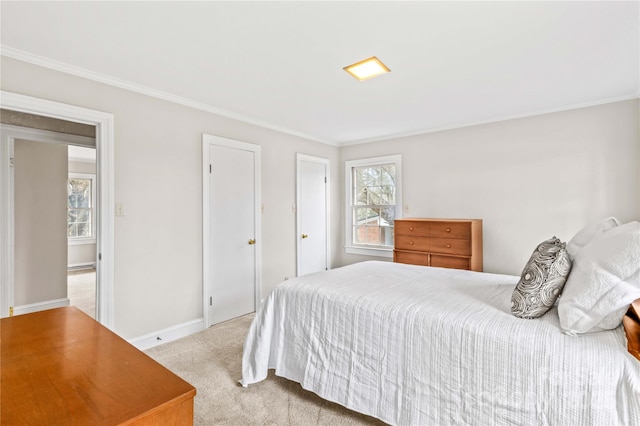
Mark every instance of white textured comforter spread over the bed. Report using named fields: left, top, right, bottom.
left=241, top=262, right=640, bottom=426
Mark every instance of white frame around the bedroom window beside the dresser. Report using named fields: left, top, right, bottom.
left=344, top=154, right=402, bottom=258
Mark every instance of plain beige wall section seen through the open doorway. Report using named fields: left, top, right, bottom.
left=14, top=139, right=67, bottom=307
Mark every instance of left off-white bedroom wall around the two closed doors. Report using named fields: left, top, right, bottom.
left=1, top=57, right=340, bottom=338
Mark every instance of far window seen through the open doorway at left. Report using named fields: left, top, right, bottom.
left=67, top=173, right=96, bottom=244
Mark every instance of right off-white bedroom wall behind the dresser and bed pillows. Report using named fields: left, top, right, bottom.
left=340, top=99, right=640, bottom=275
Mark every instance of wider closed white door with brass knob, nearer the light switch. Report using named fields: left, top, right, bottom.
left=203, top=135, right=260, bottom=326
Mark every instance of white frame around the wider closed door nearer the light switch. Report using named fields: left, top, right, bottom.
left=202, top=133, right=262, bottom=328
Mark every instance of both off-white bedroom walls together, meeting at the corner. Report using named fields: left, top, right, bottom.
left=1, top=57, right=640, bottom=338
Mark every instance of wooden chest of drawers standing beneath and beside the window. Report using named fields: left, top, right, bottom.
left=393, top=218, right=482, bottom=271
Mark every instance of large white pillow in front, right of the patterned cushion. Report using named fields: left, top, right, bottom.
left=558, top=222, right=640, bottom=334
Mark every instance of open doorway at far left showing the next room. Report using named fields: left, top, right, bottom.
left=1, top=120, right=97, bottom=318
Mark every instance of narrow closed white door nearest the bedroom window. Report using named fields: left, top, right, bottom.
left=296, top=154, right=329, bottom=276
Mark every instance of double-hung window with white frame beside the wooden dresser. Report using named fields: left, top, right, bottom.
left=345, top=155, right=402, bottom=257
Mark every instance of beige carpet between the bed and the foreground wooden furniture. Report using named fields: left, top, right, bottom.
left=146, top=314, right=383, bottom=426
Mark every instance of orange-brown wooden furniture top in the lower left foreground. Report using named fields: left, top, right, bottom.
left=0, top=307, right=196, bottom=426
